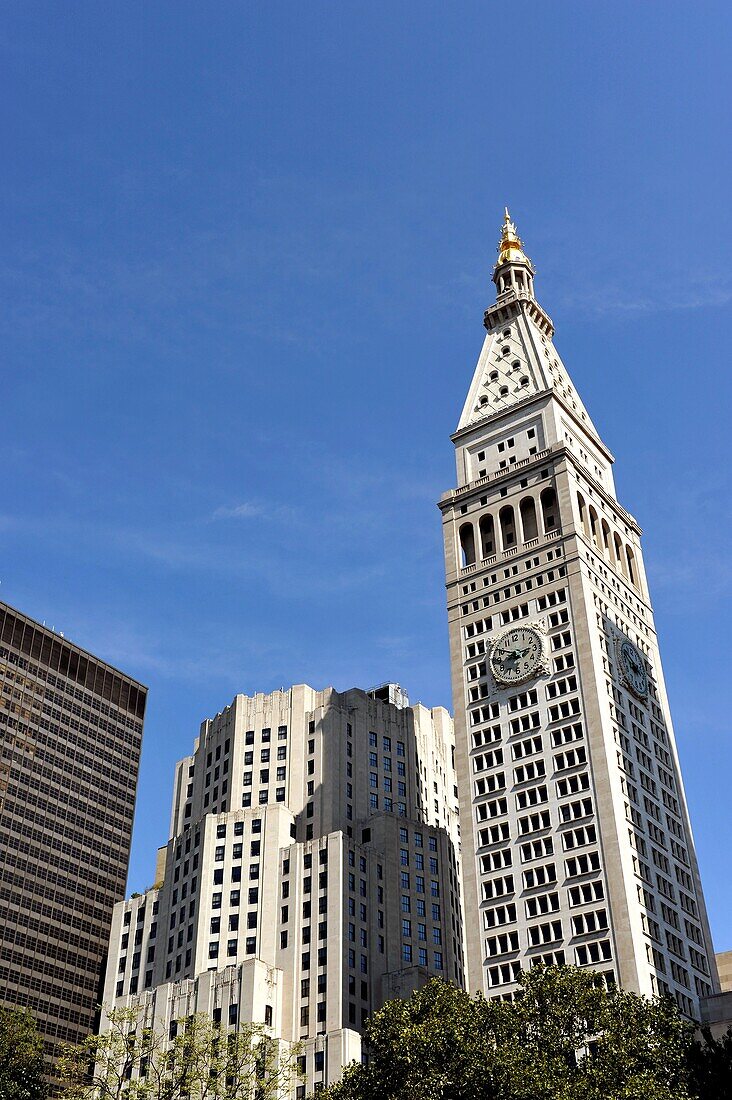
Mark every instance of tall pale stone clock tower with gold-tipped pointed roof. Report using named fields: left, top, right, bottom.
left=439, top=210, right=719, bottom=1016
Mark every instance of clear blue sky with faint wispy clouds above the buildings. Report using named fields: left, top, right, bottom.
left=0, top=0, right=732, bottom=949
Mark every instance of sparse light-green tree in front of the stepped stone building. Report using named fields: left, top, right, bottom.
left=59, top=1005, right=298, bottom=1100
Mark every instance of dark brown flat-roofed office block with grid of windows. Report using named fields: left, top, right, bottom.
left=0, top=604, right=146, bottom=1059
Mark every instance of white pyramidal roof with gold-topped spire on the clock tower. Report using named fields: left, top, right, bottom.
left=458, top=209, right=600, bottom=440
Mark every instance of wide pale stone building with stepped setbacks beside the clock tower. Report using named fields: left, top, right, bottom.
left=102, top=684, right=463, bottom=1096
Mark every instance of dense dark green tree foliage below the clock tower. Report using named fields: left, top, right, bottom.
left=321, top=967, right=732, bottom=1100
